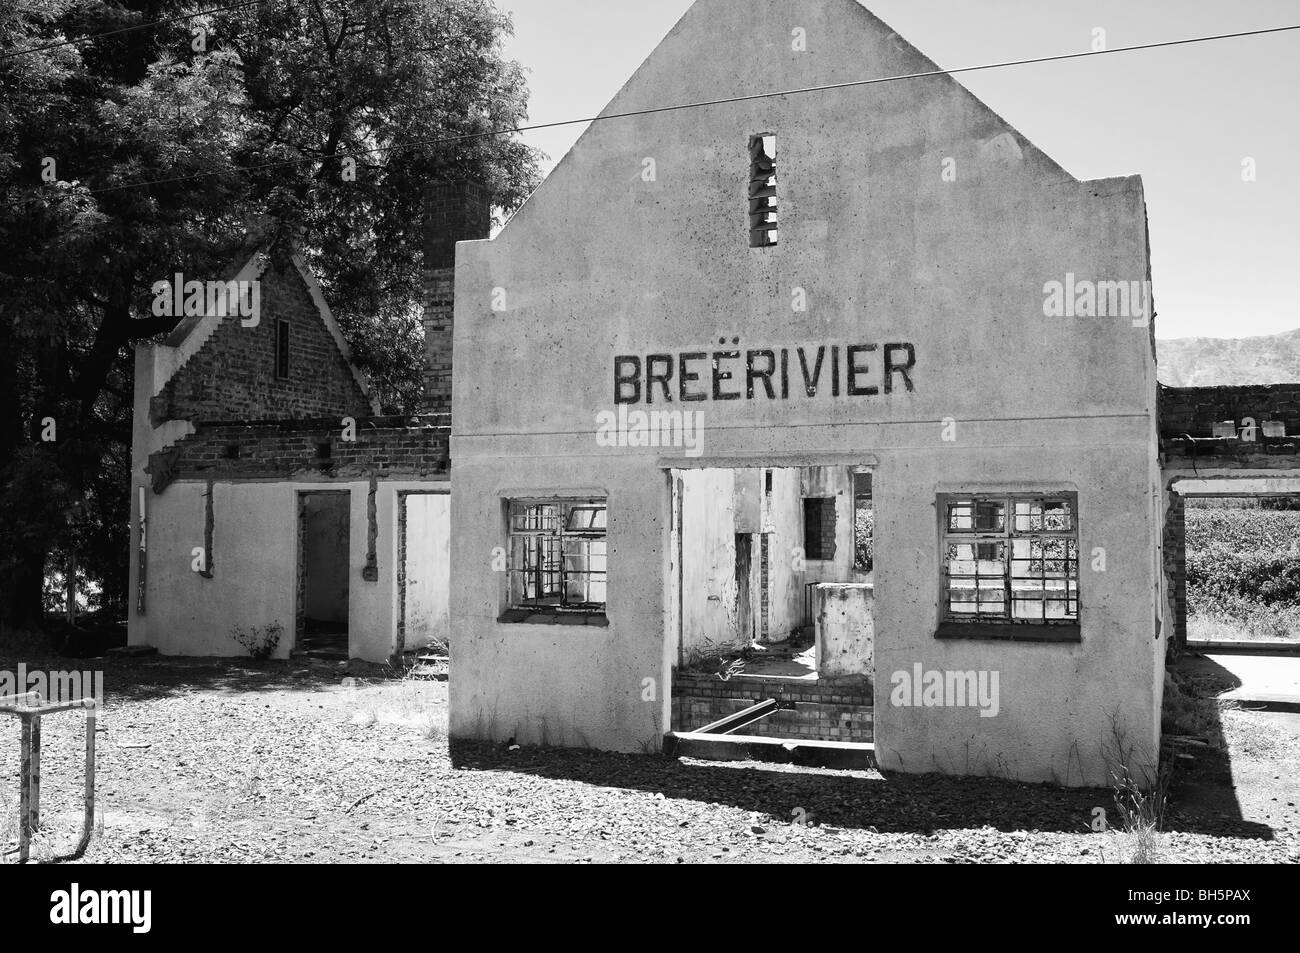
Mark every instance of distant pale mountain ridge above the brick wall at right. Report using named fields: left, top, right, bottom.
left=1156, top=328, right=1300, bottom=387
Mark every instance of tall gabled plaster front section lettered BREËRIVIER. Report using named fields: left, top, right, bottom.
left=451, top=0, right=1170, bottom=784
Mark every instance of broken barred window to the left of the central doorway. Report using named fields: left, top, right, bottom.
left=510, top=499, right=606, bottom=612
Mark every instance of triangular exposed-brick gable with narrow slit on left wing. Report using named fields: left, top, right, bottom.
left=150, top=247, right=373, bottom=425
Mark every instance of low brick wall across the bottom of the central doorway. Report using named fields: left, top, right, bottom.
left=672, top=675, right=872, bottom=742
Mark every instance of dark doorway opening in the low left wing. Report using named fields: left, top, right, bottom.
left=296, top=490, right=351, bottom=658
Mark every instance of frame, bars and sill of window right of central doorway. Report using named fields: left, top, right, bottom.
left=935, top=490, right=1083, bottom=642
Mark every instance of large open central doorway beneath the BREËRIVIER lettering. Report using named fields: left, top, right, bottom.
left=666, top=465, right=875, bottom=745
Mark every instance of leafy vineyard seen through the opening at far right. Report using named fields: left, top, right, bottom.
left=1186, top=499, right=1300, bottom=640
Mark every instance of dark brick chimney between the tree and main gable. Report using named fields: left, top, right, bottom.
left=421, top=181, right=491, bottom=413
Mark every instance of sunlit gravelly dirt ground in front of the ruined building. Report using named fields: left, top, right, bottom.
left=0, top=658, right=1300, bottom=863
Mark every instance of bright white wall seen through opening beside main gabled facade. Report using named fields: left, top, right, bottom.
left=403, top=493, right=451, bottom=649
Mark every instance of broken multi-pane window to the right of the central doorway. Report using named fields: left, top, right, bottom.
left=940, top=495, right=1079, bottom=623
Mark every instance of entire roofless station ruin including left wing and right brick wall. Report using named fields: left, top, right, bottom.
left=130, top=0, right=1300, bottom=785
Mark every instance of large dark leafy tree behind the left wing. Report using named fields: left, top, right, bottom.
left=0, top=0, right=537, bottom=625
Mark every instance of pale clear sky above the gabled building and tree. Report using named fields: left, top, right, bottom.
left=497, top=0, right=1300, bottom=338
